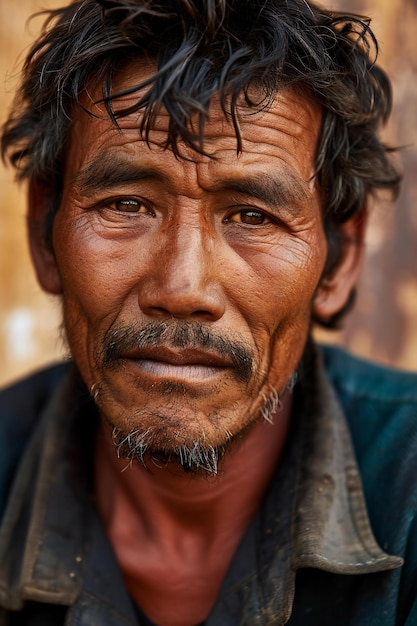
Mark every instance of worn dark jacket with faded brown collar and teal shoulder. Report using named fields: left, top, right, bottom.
left=0, top=349, right=417, bottom=626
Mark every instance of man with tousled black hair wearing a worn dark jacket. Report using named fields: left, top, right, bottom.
left=0, top=0, right=417, bottom=626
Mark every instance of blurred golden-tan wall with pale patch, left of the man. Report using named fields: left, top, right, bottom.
left=0, top=0, right=61, bottom=384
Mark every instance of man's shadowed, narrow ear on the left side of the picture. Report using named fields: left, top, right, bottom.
left=27, top=180, right=61, bottom=294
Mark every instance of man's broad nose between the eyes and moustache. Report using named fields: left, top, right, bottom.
left=139, top=223, right=225, bottom=321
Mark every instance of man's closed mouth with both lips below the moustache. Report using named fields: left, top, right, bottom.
left=124, top=347, right=233, bottom=383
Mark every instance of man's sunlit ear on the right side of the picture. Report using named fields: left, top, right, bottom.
left=313, top=213, right=367, bottom=320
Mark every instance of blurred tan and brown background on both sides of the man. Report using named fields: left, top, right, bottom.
left=0, top=0, right=417, bottom=386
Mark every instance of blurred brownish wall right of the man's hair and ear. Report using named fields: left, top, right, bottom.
left=316, top=0, right=417, bottom=370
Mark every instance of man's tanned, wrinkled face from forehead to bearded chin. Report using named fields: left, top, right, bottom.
left=39, top=70, right=327, bottom=466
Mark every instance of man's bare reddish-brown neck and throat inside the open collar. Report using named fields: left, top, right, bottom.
left=95, top=394, right=291, bottom=626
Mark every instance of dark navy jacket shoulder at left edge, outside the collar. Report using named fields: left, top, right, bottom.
left=0, top=363, right=71, bottom=517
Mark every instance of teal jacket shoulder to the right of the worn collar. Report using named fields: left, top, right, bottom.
left=323, top=347, right=417, bottom=562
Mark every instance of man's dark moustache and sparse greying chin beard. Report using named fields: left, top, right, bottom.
left=83, top=320, right=296, bottom=476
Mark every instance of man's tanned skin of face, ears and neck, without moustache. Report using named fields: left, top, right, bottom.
left=30, top=66, right=362, bottom=626
